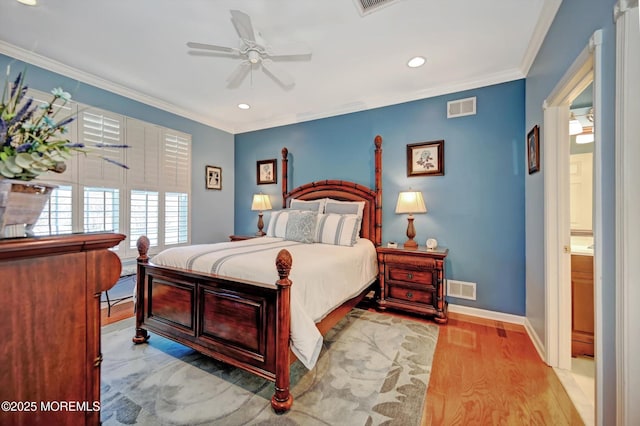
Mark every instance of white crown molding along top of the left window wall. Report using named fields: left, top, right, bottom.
left=0, top=40, right=233, bottom=133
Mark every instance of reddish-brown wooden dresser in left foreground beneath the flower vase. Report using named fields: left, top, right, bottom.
left=0, top=233, right=125, bottom=425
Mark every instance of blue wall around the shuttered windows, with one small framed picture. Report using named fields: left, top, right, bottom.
left=0, top=54, right=234, bottom=243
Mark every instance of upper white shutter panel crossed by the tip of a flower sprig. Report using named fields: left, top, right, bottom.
left=78, top=109, right=126, bottom=187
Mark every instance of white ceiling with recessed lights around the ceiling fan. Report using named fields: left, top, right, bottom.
left=0, top=0, right=561, bottom=133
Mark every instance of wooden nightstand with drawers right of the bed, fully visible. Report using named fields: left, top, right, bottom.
left=377, top=246, right=449, bottom=324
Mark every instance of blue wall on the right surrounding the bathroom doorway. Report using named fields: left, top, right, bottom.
left=525, top=0, right=616, bottom=425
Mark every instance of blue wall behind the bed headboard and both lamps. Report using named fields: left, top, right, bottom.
left=235, top=80, right=526, bottom=315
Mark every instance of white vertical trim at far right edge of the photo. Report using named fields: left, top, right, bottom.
left=614, top=0, right=640, bottom=425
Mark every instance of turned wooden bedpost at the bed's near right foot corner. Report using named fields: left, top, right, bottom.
left=271, top=250, right=293, bottom=414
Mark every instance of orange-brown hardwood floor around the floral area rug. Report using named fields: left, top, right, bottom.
left=102, top=302, right=584, bottom=426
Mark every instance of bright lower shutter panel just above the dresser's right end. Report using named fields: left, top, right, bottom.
left=84, top=187, right=120, bottom=232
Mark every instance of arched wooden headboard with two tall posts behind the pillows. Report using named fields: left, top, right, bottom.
left=281, top=135, right=382, bottom=247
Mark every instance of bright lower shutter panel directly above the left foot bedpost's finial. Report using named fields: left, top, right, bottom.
left=129, top=190, right=160, bottom=249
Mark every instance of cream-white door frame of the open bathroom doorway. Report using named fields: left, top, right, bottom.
left=543, top=30, right=603, bottom=424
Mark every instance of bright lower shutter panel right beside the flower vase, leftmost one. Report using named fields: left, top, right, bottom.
left=33, top=186, right=73, bottom=235
